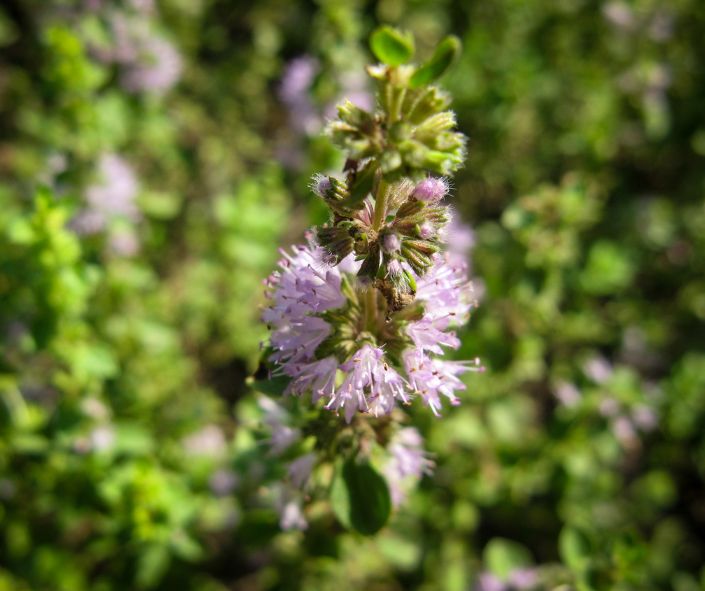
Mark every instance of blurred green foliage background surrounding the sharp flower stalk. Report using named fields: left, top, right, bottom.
left=0, top=0, right=705, bottom=591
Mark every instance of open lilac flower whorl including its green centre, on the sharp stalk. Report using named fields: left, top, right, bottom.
left=263, top=242, right=477, bottom=422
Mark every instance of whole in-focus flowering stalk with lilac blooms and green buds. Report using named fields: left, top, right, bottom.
left=256, top=27, right=481, bottom=534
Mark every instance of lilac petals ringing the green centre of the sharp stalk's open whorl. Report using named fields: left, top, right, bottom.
left=263, top=238, right=481, bottom=422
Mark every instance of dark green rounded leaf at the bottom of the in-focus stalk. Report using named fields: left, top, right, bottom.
left=330, top=460, right=392, bottom=536
